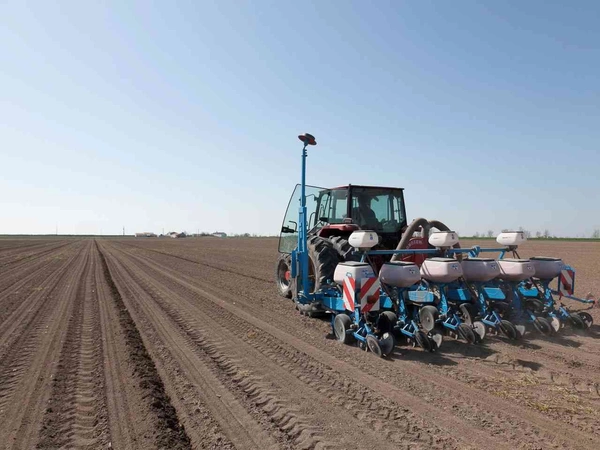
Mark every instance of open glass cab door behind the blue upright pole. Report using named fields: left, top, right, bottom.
left=279, top=184, right=324, bottom=253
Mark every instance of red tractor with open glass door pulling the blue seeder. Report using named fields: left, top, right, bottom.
left=275, top=185, right=412, bottom=298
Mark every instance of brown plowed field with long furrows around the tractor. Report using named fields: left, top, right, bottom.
left=0, top=238, right=600, bottom=449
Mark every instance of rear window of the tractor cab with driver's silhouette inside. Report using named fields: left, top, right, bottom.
left=352, top=186, right=406, bottom=233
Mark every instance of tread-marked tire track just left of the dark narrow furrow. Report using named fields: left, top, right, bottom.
left=37, top=243, right=110, bottom=449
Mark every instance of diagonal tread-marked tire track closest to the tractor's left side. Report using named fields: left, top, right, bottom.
left=106, top=244, right=509, bottom=448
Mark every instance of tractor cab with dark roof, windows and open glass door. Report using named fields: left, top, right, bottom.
left=279, top=185, right=406, bottom=253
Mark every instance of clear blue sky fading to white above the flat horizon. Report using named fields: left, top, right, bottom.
left=0, top=0, right=600, bottom=236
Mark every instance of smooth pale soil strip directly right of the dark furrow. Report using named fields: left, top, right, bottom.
left=103, top=243, right=280, bottom=450
